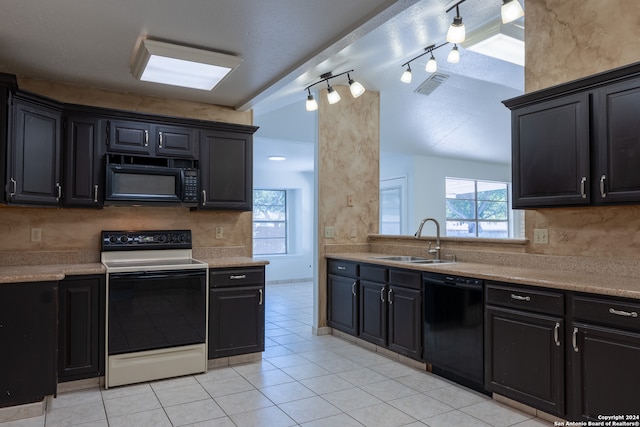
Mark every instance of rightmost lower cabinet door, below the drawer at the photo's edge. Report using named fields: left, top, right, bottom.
left=567, top=323, right=640, bottom=421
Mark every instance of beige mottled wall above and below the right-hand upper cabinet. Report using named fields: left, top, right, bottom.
left=525, top=0, right=640, bottom=259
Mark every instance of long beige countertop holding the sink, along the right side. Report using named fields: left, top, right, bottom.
left=325, top=252, right=640, bottom=299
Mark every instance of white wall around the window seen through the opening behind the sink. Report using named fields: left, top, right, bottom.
left=380, top=152, right=518, bottom=236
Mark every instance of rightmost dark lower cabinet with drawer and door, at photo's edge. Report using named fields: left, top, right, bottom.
left=567, top=296, right=640, bottom=422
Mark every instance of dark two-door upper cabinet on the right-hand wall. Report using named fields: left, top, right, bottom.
left=504, top=63, right=640, bottom=208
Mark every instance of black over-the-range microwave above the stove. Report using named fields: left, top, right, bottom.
left=104, top=161, right=200, bottom=206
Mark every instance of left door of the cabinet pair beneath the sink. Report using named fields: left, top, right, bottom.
left=359, top=280, right=387, bottom=346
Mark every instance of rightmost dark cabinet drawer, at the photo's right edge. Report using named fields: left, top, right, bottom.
left=571, top=296, right=640, bottom=331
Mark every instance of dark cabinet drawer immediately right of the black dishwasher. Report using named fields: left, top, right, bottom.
left=486, top=282, right=564, bottom=315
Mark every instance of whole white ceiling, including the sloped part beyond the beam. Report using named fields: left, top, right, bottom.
left=0, top=0, right=523, bottom=172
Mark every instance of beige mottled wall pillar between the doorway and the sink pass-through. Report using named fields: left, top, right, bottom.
left=316, top=86, right=380, bottom=326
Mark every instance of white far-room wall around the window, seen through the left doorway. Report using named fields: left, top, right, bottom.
left=253, top=167, right=313, bottom=283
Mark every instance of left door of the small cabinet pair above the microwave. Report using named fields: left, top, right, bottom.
left=106, top=120, right=155, bottom=155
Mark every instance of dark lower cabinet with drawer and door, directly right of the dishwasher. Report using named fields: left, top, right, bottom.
left=484, top=282, right=566, bottom=416
